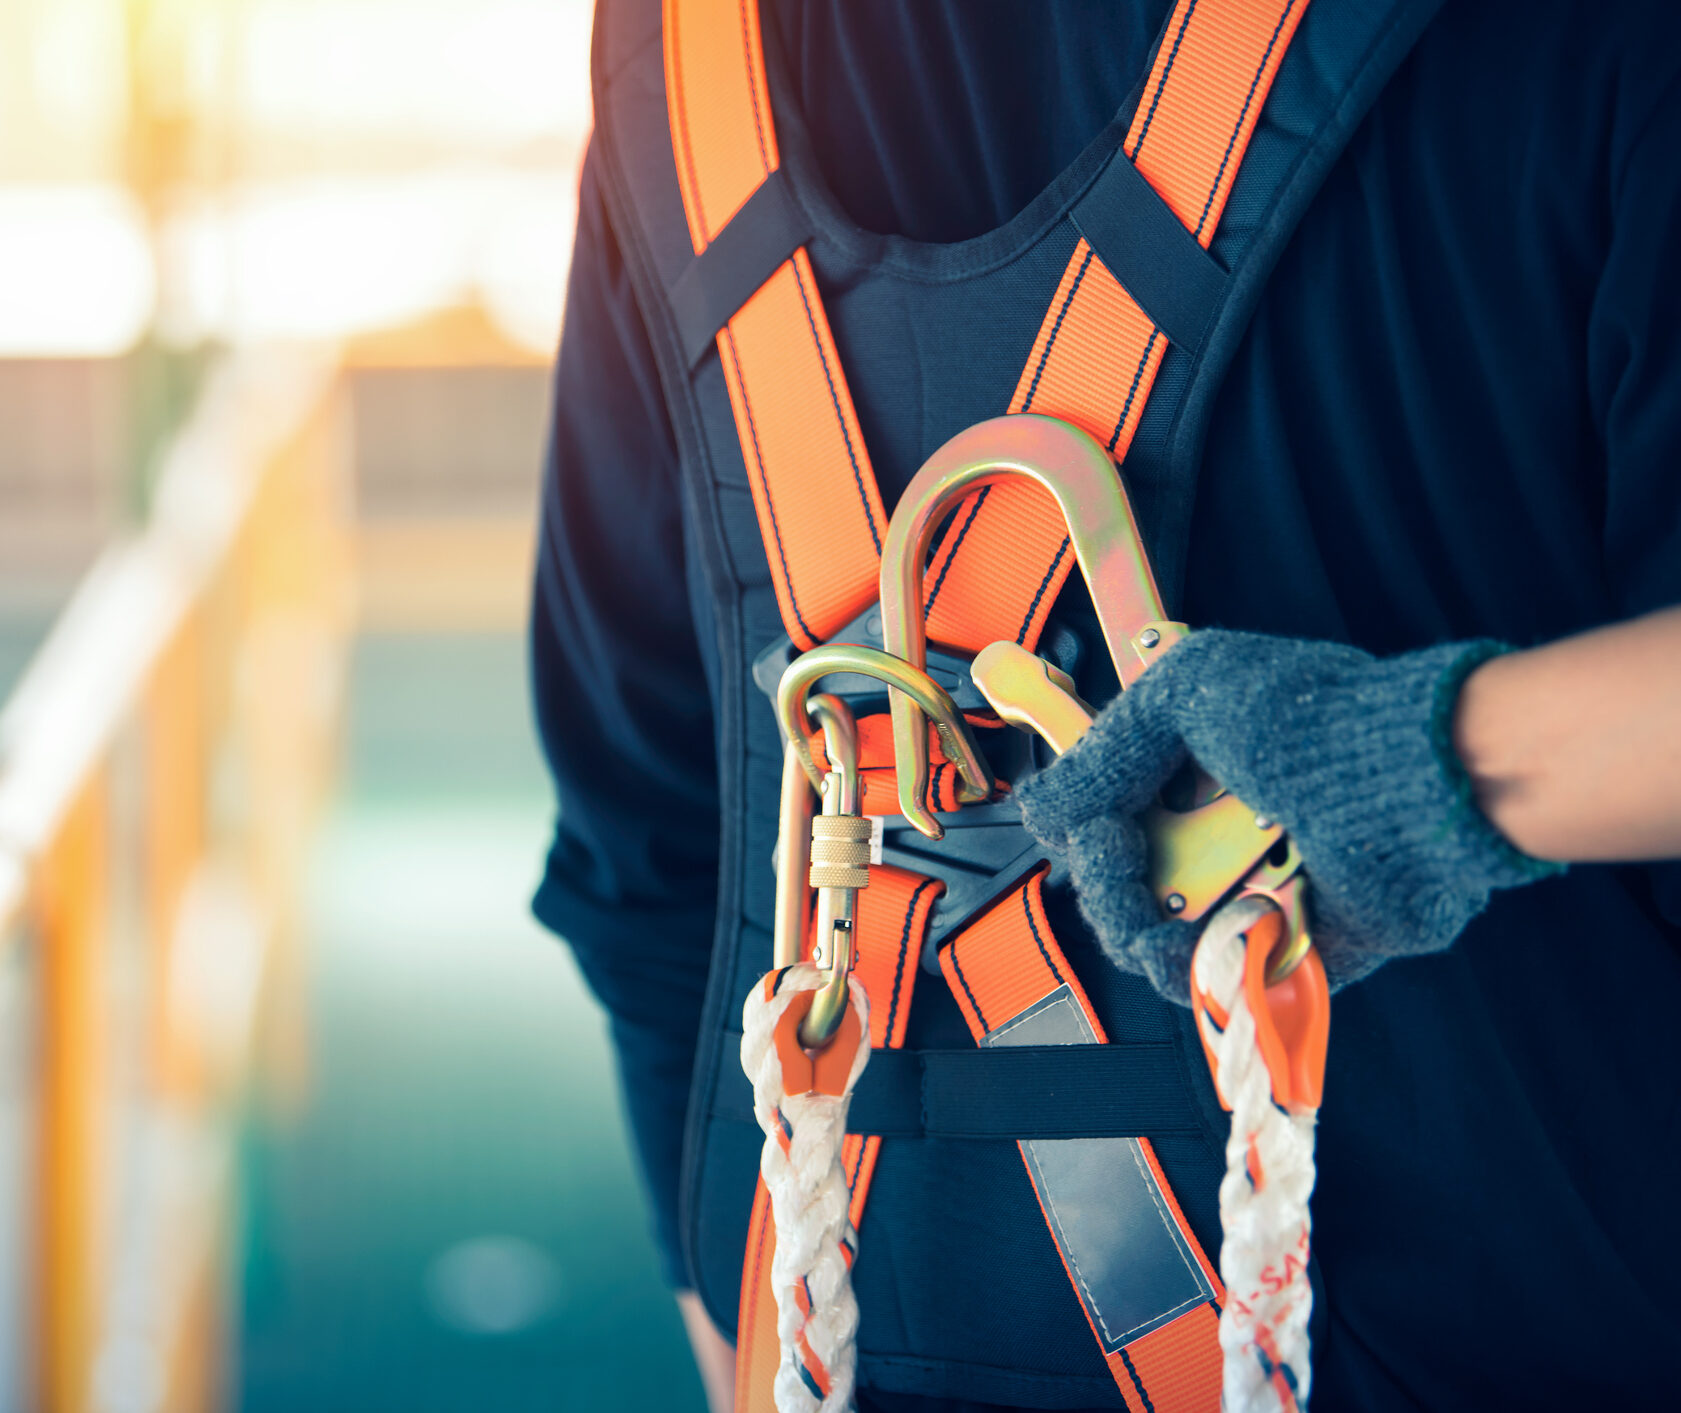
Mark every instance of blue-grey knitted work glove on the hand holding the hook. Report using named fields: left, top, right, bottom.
left=1015, top=628, right=1562, bottom=1005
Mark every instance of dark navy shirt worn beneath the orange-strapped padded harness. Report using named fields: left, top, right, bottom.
left=533, top=0, right=1681, bottom=1406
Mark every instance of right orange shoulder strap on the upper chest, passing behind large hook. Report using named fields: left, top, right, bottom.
left=925, top=0, right=1308, bottom=652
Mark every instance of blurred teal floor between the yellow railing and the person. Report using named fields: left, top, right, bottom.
left=237, top=637, right=703, bottom=1413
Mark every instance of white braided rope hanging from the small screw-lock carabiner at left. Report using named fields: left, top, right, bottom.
left=741, top=963, right=869, bottom=1413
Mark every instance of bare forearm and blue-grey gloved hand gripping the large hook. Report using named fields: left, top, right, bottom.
left=1017, top=610, right=1681, bottom=1001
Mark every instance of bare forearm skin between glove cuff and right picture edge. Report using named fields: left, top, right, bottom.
left=1454, top=608, right=1681, bottom=862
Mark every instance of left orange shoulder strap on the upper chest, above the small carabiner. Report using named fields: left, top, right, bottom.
left=666, top=0, right=888, bottom=649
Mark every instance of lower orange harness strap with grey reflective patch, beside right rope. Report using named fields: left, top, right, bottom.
left=940, top=874, right=1225, bottom=1413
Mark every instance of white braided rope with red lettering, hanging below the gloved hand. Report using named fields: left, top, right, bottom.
left=1192, top=897, right=1318, bottom=1413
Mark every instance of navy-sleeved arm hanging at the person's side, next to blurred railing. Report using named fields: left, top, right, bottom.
left=531, top=143, right=718, bottom=1285
